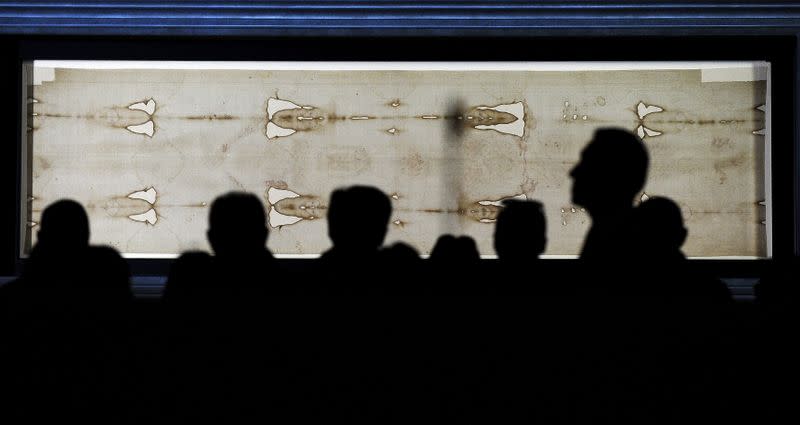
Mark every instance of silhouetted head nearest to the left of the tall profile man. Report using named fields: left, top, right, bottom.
left=494, top=200, right=547, bottom=260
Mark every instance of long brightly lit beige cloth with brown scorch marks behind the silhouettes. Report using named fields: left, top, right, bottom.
left=21, top=61, right=770, bottom=257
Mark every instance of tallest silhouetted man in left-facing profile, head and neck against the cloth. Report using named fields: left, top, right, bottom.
left=570, top=128, right=649, bottom=261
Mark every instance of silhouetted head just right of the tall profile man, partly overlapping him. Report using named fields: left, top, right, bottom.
left=635, top=197, right=688, bottom=254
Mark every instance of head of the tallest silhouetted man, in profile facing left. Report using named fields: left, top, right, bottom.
left=569, top=128, right=650, bottom=213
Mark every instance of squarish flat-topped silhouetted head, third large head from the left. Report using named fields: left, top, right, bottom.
left=328, top=186, right=392, bottom=251
